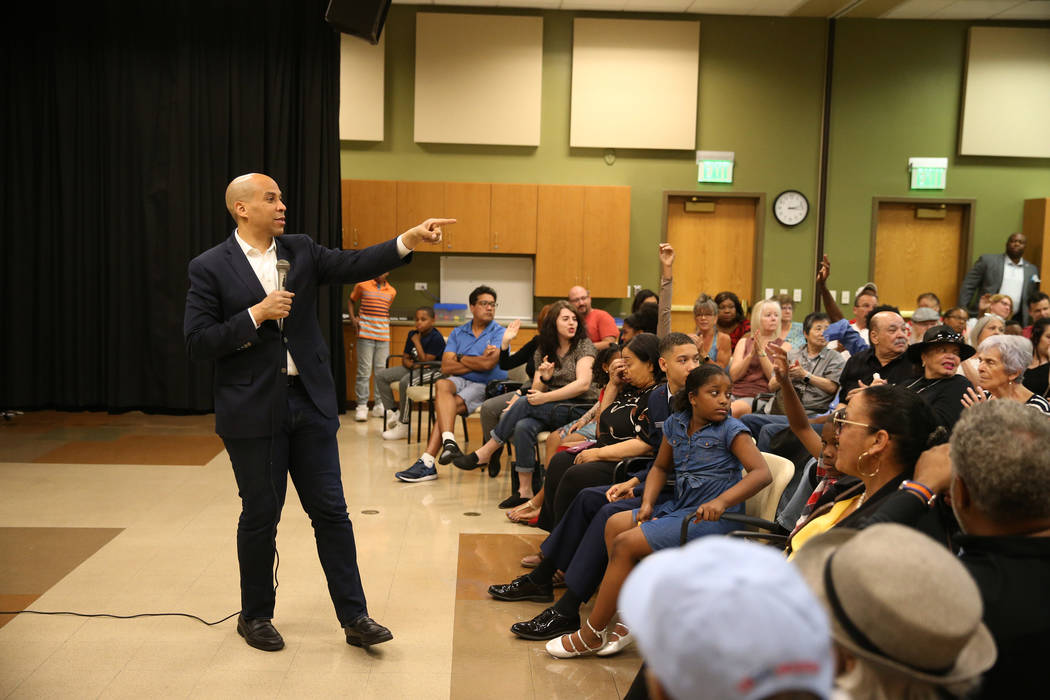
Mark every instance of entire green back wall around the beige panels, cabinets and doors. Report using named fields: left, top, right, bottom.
left=341, top=5, right=1050, bottom=313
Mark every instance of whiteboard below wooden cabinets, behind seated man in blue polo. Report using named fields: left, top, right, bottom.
left=441, top=255, right=533, bottom=320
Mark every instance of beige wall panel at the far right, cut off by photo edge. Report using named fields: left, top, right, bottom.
left=959, top=26, right=1050, bottom=158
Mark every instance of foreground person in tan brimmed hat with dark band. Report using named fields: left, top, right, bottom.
left=795, top=523, right=1003, bottom=700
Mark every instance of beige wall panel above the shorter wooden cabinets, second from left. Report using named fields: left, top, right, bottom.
left=415, top=13, right=543, bottom=146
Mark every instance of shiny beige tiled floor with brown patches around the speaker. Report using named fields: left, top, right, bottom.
left=0, top=413, right=639, bottom=699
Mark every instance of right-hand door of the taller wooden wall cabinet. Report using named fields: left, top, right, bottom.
left=580, top=187, right=631, bottom=298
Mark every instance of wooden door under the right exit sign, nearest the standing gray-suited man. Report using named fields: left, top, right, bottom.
left=873, top=201, right=969, bottom=313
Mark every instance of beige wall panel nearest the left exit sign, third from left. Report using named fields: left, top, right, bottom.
left=569, top=18, right=700, bottom=150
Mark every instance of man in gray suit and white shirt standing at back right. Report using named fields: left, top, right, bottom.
left=959, top=233, right=1040, bottom=325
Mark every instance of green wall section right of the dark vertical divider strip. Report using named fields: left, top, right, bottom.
left=825, top=20, right=1050, bottom=298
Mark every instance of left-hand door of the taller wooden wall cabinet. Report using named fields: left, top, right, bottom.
left=533, top=185, right=586, bottom=297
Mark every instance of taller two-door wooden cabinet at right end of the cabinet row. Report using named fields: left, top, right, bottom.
left=536, top=185, right=631, bottom=297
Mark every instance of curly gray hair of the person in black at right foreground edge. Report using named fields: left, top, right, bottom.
left=951, top=400, right=1050, bottom=523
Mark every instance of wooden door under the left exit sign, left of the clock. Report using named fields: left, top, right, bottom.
left=667, top=195, right=758, bottom=333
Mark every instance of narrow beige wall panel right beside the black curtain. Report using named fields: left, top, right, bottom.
left=339, top=35, right=386, bottom=141
